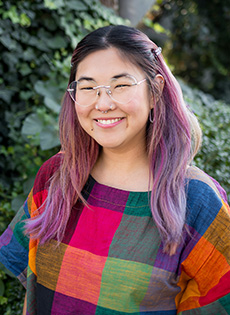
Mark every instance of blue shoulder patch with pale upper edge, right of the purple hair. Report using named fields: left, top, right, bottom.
left=186, top=166, right=228, bottom=235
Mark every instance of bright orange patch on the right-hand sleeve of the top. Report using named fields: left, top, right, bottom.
left=176, top=237, right=230, bottom=312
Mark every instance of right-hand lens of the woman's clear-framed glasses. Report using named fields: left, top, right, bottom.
left=110, top=76, right=137, bottom=104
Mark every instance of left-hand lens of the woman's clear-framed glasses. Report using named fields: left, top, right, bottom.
left=68, top=80, right=97, bottom=106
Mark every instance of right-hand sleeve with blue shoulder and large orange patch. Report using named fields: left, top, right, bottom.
left=176, top=168, right=230, bottom=315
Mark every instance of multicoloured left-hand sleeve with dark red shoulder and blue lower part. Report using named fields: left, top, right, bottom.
left=0, top=153, right=62, bottom=287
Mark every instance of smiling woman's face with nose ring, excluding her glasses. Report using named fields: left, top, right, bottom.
left=75, top=48, right=153, bottom=154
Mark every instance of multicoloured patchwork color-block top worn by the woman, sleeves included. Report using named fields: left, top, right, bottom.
left=0, top=154, right=230, bottom=315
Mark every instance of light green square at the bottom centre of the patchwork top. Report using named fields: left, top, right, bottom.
left=98, top=257, right=153, bottom=313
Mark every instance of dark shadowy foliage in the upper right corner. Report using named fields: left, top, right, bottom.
left=144, top=0, right=230, bottom=103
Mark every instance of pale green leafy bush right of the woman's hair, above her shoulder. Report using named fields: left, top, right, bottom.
left=180, top=81, right=230, bottom=200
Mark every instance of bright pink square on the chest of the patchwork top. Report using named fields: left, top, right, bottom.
left=69, top=206, right=123, bottom=256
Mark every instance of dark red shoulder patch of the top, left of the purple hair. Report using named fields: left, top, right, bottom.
left=33, top=152, right=63, bottom=194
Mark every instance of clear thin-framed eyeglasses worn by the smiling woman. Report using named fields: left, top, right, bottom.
left=67, top=75, right=146, bottom=106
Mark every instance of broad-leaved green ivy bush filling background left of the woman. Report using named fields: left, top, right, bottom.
left=0, top=0, right=124, bottom=209
